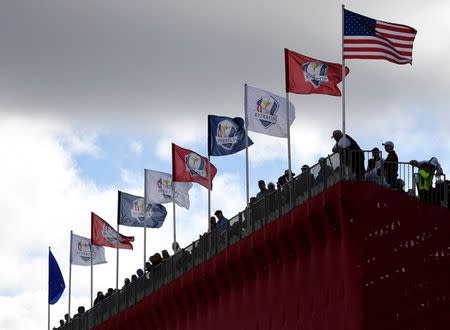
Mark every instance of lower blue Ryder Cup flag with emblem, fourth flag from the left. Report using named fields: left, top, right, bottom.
left=119, top=191, right=167, bottom=228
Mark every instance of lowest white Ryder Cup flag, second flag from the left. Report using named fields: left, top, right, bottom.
left=70, top=234, right=106, bottom=266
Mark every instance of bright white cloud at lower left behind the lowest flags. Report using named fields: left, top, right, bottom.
left=0, top=116, right=248, bottom=329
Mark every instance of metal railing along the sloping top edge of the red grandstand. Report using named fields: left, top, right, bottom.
left=59, top=150, right=448, bottom=330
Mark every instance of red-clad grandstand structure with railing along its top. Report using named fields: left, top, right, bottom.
left=61, top=154, right=450, bottom=330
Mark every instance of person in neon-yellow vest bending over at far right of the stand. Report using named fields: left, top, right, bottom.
left=409, top=157, right=444, bottom=203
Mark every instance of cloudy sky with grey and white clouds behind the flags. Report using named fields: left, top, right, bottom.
left=0, top=0, right=450, bottom=329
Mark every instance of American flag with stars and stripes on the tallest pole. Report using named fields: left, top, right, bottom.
left=344, top=9, right=417, bottom=64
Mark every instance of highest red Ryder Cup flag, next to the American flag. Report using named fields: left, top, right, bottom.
left=284, top=48, right=350, bottom=96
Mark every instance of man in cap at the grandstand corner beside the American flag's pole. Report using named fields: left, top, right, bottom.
left=331, top=129, right=365, bottom=180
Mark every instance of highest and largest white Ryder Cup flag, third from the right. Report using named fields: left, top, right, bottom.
left=245, top=86, right=295, bottom=138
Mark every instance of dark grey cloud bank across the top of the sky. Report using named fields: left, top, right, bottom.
left=0, top=0, right=450, bottom=131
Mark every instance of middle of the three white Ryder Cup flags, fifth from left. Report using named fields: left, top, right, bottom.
left=145, top=170, right=192, bottom=209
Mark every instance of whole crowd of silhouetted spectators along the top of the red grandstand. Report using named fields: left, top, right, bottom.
left=54, top=130, right=450, bottom=326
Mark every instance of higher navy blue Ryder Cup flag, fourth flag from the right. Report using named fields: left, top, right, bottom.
left=208, top=115, right=253, bottom=156
